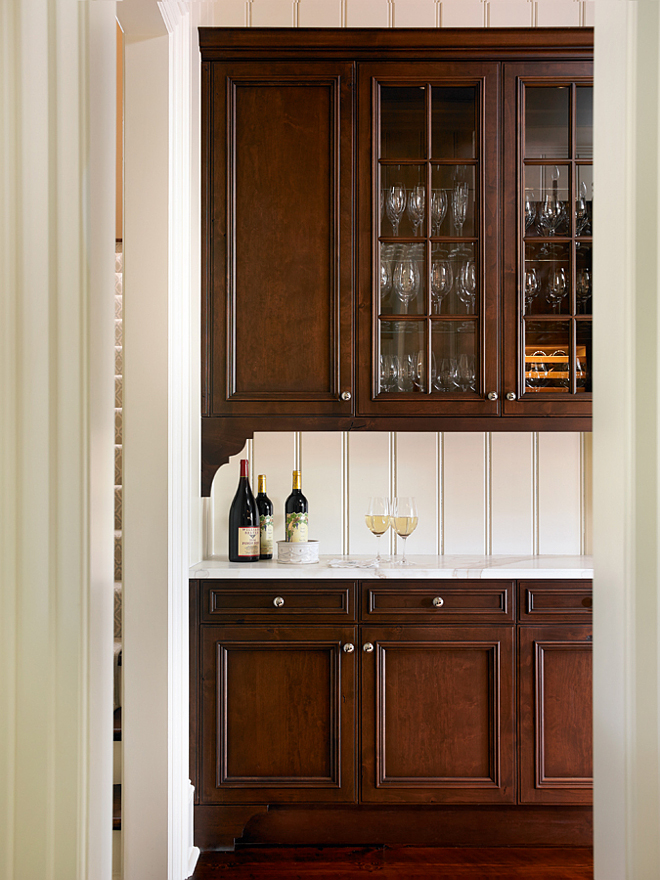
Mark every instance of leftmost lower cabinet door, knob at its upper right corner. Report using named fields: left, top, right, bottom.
left=200, top=626, right=356, bottom=804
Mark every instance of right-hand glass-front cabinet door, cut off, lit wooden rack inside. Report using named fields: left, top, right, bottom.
left=503, top=64, right=593, bottom=416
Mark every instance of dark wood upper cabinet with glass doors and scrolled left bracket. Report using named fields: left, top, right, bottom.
left=200, top=28, right=593, bottom=494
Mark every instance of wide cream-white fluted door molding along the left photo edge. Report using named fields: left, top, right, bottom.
left=0, top=0, right=116, bottom=880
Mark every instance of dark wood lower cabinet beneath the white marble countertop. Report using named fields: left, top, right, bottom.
left=191, top=579, right=591, bottom=846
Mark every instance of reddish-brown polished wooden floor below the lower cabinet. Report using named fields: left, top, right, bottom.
left=194, top=846, right=593, bottom=880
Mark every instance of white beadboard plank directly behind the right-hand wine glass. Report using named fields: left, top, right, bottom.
left=395, top=431, right=440, bottom=553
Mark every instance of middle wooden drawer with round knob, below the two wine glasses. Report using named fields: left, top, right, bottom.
left=362, top=580, right=514, bottom=624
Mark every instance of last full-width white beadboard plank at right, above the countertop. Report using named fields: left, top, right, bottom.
left=538, top=433, right=582, bottom=555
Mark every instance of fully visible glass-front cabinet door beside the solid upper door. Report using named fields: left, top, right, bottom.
left=357, top=63, right=500, bottom=416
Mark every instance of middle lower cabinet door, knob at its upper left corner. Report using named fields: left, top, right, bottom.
left=361, top=626, right=515, bottom=804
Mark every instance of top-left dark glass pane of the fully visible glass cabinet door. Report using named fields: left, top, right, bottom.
left=380, top=86, right=426, bottom=159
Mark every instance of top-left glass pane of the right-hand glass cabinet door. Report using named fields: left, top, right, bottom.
left=525, top=86, right=570, bottom=159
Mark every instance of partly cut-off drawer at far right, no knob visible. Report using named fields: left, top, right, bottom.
left=518, top=580, right=592, bottom=623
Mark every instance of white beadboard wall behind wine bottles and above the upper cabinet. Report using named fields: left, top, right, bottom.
left=203, top=0, right=595, bottom=556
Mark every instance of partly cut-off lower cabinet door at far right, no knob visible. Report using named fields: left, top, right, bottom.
left=518, top=625, right=593, bottom=804
